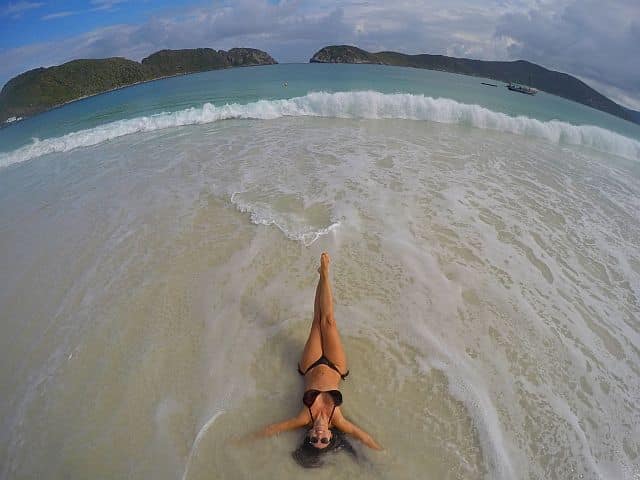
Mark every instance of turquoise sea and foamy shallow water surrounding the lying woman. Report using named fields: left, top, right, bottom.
left=0, top=64, right=640, bottom=480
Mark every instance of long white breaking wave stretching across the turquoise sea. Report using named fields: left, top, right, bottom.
left=0, top=91, right=640, bottom=167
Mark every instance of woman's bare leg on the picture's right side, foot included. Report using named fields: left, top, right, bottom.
left=317, top=252, right=347, bottom=373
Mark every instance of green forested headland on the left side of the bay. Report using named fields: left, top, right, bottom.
left=0, top=48, right=278, bottom=124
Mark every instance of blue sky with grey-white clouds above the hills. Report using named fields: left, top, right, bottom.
left=0, top=0, right=640, bottom=109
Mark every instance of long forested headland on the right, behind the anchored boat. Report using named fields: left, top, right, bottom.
left=310, top=45, right=640, bottom=123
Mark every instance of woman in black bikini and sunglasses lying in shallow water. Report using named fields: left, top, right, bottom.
left=249, top=253, right=382, bottom=467
